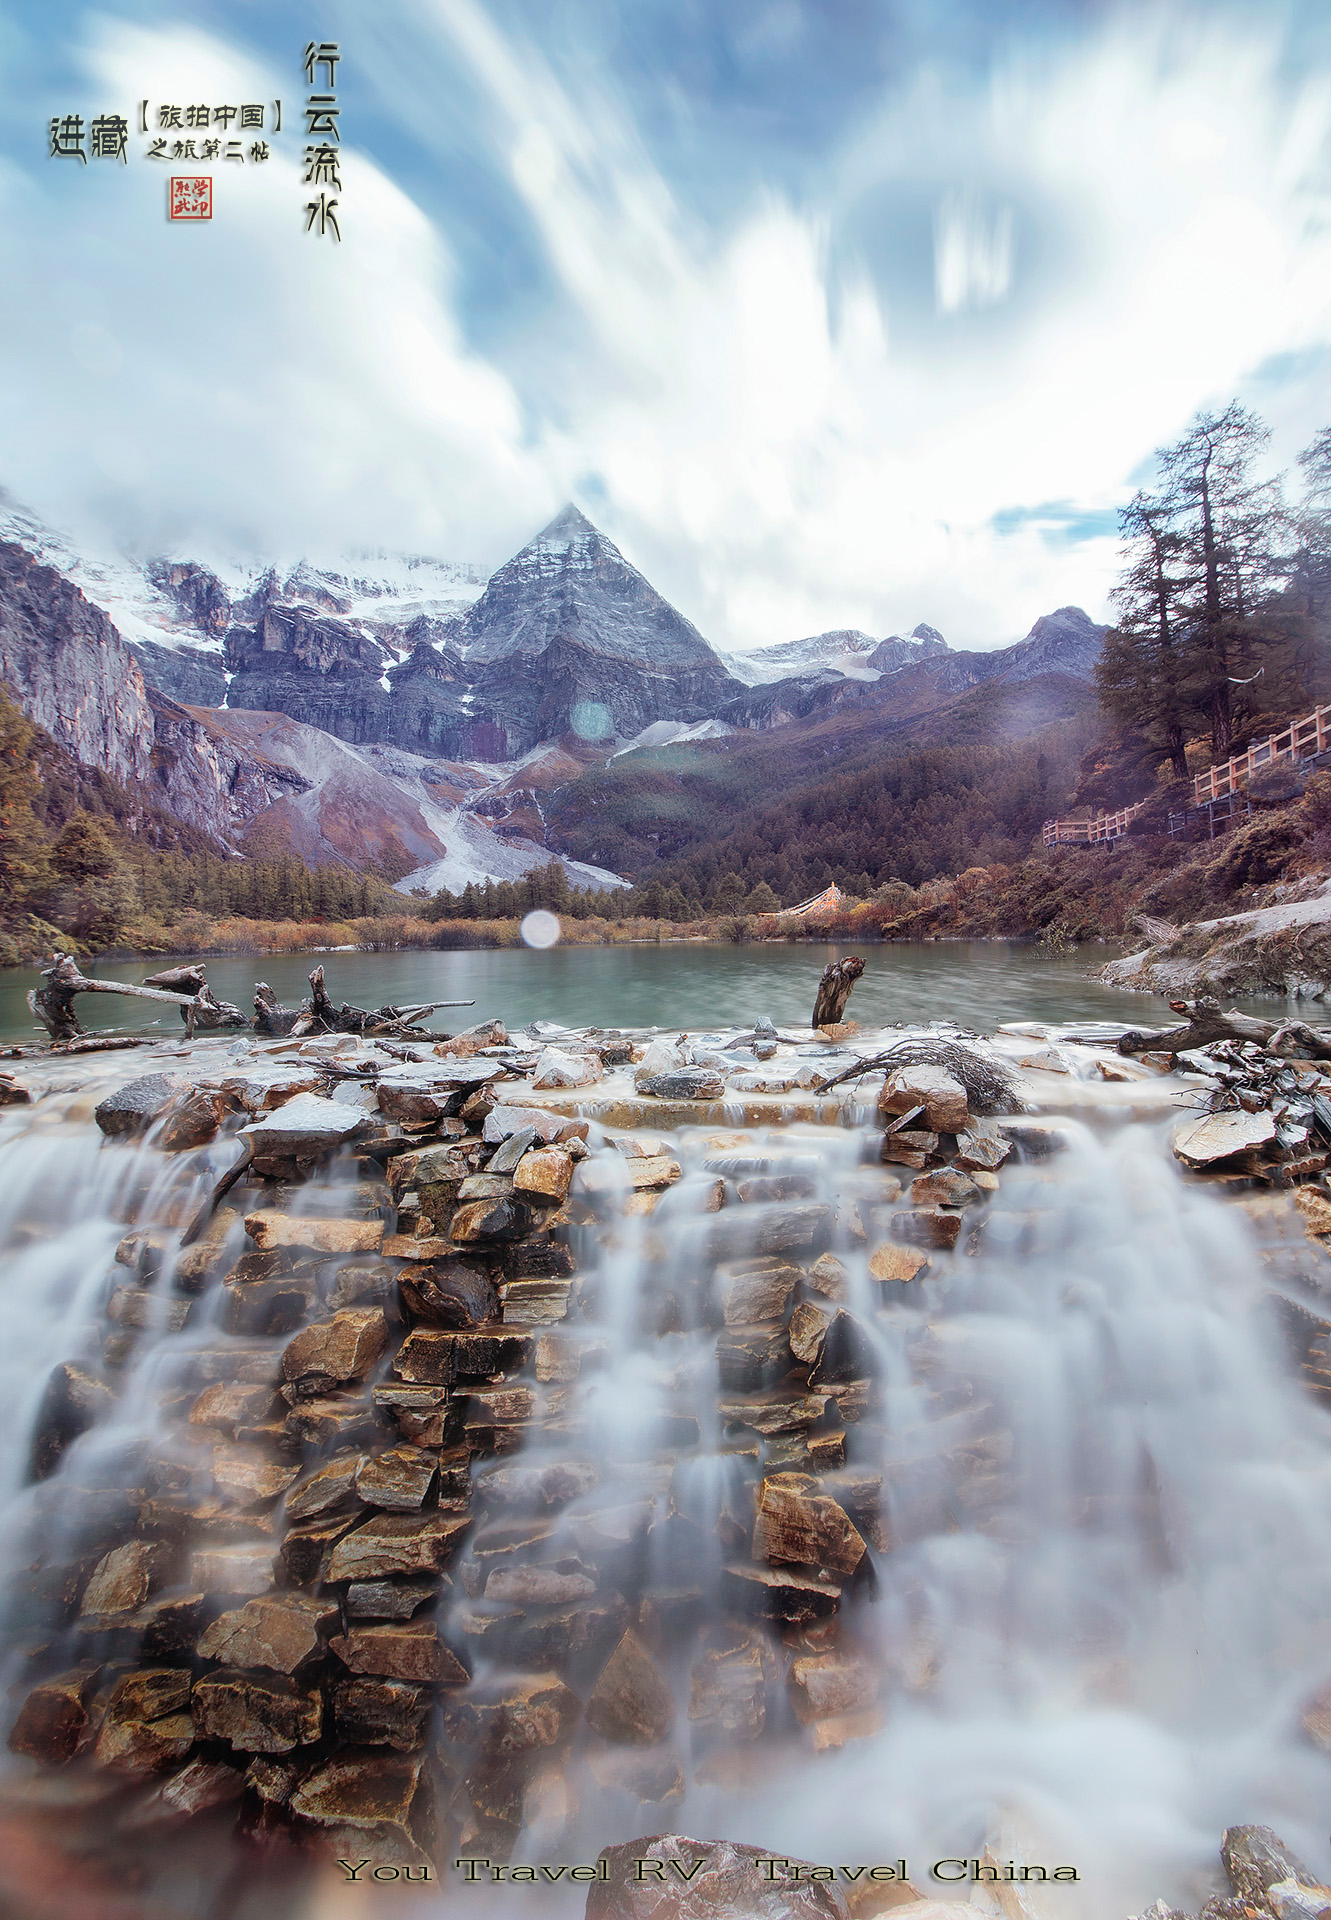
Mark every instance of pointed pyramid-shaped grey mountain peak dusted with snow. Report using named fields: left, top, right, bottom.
left=448, top=505, right=743, bottom=755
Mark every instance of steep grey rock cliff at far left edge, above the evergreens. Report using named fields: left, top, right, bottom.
left=0, top=541, right=152, bottom=783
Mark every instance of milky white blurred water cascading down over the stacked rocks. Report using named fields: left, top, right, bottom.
left=0, top=998, right=1331, bottom=1920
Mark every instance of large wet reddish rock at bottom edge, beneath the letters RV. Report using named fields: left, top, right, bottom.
left=586, top=1834, right=851, bottom=1920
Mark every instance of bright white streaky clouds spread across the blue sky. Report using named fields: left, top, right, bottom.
left=0, top=0, right=1331, bottom=645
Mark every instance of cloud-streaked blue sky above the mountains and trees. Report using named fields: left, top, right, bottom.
left=0, top=0, right=1331, bottom=645
